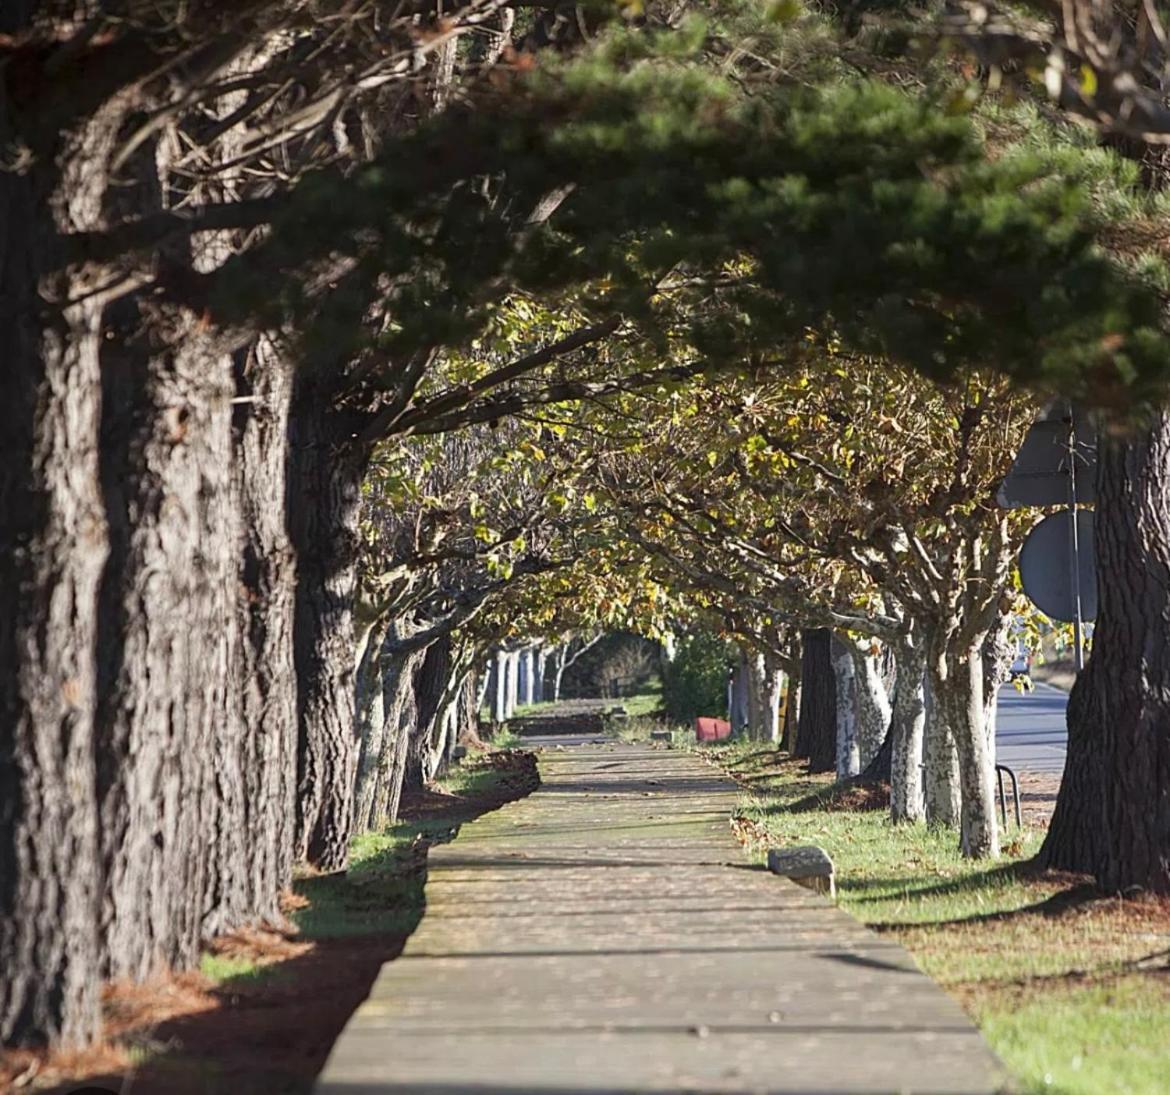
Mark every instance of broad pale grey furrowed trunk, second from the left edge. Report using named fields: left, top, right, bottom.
left=97, top=315, right=247, bottom=979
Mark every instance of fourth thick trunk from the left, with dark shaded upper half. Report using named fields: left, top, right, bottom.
left=288, top=388, right=370, bottom=870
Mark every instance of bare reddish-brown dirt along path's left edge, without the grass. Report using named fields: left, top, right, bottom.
left=0, top=752, right=537, bottom=1095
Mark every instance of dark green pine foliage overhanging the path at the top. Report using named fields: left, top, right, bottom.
left=216, top=5, right=1170, bottom=406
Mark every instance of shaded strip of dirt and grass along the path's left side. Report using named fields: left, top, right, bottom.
left=21, top=752, right=537, bottom=1095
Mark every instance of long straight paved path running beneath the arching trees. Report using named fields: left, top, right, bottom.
left=317, top=743, right=1003, bottom=1095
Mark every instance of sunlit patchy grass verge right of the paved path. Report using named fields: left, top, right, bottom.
left=702, top=743, right=1170, bottom=1095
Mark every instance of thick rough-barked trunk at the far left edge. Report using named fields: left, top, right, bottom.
left=0, top=198, right=106, bottom=1046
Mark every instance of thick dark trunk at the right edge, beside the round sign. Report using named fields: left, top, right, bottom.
left=1038, top=412, right=1170, bottom=894
